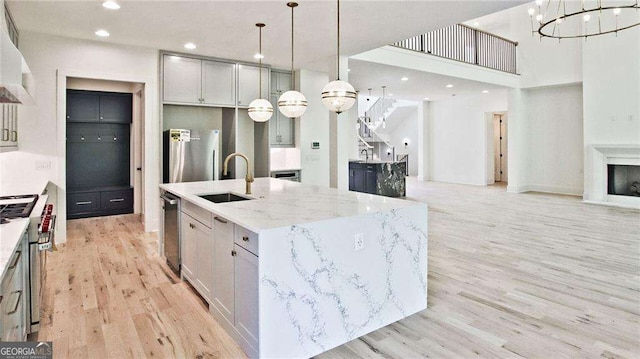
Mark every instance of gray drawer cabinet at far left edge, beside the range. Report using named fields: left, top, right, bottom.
left=0, top=232, right=29, bottom=342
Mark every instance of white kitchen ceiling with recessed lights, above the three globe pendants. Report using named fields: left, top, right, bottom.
left=8, top=0, right=525, bottom=71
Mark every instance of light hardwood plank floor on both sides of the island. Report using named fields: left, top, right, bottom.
left=38, top=179, right=640, bottom=358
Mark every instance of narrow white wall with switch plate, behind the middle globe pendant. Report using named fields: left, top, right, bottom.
left=296, top=70, right=331, bottom=187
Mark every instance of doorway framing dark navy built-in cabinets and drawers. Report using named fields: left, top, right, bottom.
left=65, top=77, right=145, bottom=219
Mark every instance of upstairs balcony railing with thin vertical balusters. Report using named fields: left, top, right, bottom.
left=393, top=24, right=518, bottom=74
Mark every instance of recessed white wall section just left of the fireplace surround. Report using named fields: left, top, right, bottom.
left=523, top=85, right=584, bottom=195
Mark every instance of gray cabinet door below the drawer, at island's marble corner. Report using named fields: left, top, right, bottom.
left=235, top=244, right=259, bottom=351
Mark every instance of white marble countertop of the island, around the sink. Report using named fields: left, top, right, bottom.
left=160, top=178, right=425, bottom=233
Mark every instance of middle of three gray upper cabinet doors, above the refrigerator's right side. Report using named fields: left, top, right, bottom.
left=202, top=60, right=237, bottom=107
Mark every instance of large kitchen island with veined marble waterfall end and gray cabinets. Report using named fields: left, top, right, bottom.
left=160, top=178, right=427, bottom=358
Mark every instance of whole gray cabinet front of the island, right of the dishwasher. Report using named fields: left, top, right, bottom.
left=180, top=207, right=259, bottom=357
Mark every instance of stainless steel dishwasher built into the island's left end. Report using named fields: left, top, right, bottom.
left=160, top=192, right=180, bottom=275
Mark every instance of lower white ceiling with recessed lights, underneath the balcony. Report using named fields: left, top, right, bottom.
left=349, top=59, right=505, bottom=101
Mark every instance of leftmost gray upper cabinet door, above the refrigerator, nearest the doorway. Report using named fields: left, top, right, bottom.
left=163, top=55, right=202, bottom=103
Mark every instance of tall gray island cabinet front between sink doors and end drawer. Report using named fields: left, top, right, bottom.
left=209, top=216, right=235, bottom=323
